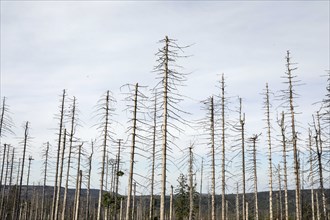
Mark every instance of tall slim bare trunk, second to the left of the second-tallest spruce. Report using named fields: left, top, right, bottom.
left=265, top=83, right=273, bottom=220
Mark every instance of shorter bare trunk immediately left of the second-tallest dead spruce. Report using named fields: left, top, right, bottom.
left=280, top=112, right=289, bottom=220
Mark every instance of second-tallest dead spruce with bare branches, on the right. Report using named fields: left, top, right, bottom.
left=282, top=51, right=301, bottom=220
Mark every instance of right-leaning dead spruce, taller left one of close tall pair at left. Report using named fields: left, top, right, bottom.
left=51, top=90, right=66, bottom=220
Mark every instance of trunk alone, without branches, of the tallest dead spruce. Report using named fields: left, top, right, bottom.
left=160, top=36, right=169, bottom=220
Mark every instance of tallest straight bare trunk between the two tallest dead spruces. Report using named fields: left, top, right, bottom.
left=221, top=74, right=226, bottom=220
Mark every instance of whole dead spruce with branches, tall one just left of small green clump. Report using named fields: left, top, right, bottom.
left=97, top=90, right=115, bottom=220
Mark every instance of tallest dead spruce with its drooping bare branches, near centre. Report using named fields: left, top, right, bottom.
left=154, top=36, right=186, bottom=220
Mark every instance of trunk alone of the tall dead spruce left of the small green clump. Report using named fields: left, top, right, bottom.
left=97, top=91, right=109, bottom=220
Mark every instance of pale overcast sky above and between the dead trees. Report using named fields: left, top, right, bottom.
left=1, top=1, right=330, bottom=192
